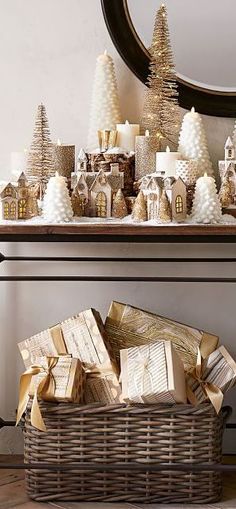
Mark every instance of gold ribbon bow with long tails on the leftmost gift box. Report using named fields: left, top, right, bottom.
left=16, top=357, right=58, bottom=431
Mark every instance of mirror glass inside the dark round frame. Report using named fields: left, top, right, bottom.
left=127, top=0, right=236, bottom=93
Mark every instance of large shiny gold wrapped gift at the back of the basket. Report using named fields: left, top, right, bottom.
left=105, top=302, right=218, bottom=371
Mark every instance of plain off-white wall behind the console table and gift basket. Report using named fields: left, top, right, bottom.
left=0, top=0, right=236, bottom=452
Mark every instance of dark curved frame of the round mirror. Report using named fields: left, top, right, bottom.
left=101, top=0, right=236, bottom=117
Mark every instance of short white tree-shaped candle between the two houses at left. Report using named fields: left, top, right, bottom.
left=43, top=172, right=73, bottom=223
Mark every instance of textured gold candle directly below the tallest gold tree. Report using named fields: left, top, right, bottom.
left=135, top=131, right=160, bottom=180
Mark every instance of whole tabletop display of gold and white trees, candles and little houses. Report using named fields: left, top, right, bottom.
left=0, top=5, right=236, bottom=226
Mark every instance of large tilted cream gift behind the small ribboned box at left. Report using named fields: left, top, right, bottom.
left=18, top=309, right=122, bottom=404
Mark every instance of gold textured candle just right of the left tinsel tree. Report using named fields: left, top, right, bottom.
left=54, top=140, right=75, bottom=179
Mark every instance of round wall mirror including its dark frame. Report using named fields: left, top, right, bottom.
left=101, top=0, right=236, bottom=117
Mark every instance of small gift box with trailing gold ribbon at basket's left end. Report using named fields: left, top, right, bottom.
left=16, top=355, right=86, bottom=431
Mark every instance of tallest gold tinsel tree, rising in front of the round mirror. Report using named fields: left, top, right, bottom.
left=141, top=5, right=180, bottom=148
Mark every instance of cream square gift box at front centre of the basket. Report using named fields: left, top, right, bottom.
left=120, top=341, right=187, bottom=404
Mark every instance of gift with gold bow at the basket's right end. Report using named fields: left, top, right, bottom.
left=187, top=346, right=236, bottom=413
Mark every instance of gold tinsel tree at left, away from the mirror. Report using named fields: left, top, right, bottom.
left=26, top=104, right=55, bottom=194
